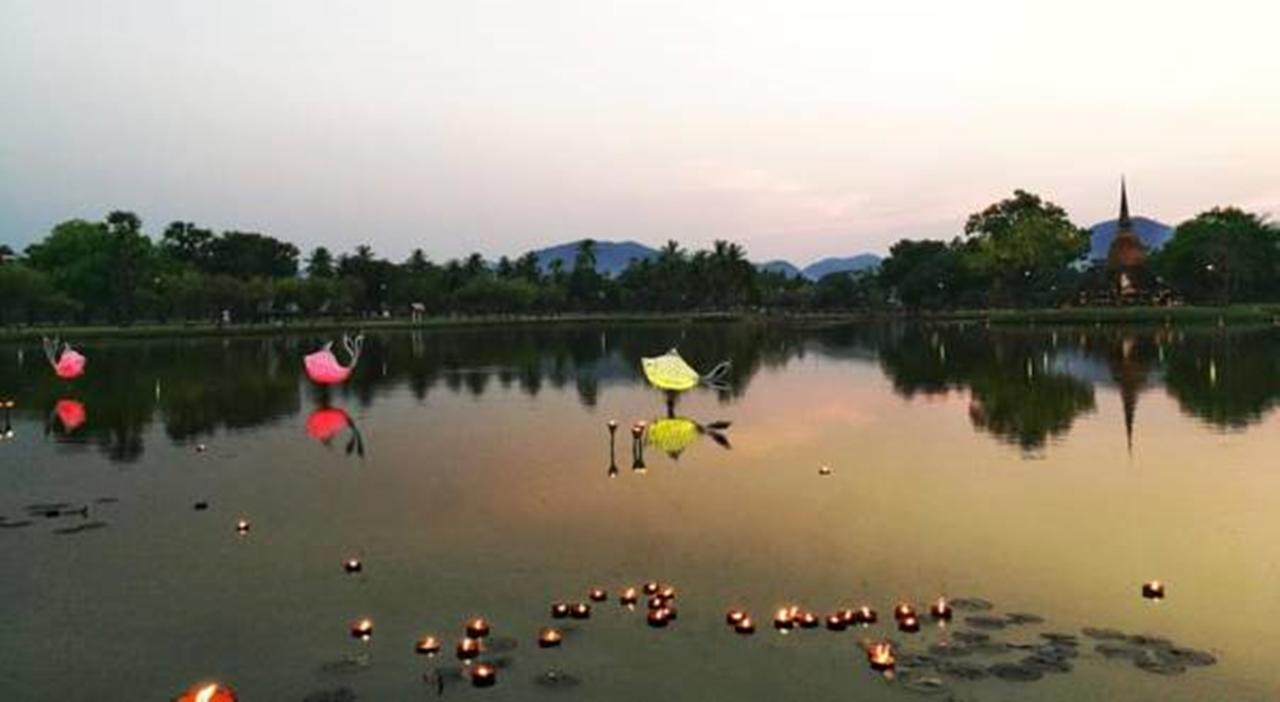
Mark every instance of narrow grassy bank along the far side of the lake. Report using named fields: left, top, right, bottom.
left=0, top=304, right=1280, bottom=342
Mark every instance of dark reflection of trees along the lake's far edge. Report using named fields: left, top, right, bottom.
left=0, top=324, right=1280, bottom=461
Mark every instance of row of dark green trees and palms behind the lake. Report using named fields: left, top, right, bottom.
left=0, top=191, right=1280, bottom=324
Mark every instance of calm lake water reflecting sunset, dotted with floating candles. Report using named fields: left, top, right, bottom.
left=0, top=323, right=1280, bottom=702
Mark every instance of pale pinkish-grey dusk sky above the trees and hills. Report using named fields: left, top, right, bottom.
left=0, top=0, right=1280, bottom=264
